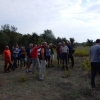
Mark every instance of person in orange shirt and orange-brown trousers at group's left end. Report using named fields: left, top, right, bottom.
left=3, top=46, right=12, bottom=72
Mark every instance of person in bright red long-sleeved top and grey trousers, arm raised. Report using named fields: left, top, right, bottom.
left=31, top=46, right=42, bottom=74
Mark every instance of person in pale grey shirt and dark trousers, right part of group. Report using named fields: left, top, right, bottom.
left=60, top=41, right=69, bottom=70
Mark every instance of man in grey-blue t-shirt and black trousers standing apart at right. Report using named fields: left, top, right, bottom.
left=89, top=39, right=100, bottom=88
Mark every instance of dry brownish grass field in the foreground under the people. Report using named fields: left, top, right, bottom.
left=0, top=52, right=100, bottom=100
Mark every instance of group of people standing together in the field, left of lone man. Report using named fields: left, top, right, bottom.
left=3, top=41, right=74, bottom=80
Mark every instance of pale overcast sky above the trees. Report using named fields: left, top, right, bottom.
left=0, top=0, right=100, bottom=42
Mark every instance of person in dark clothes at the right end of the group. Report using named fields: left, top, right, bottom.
left=68, top=42, right=74, bottom=68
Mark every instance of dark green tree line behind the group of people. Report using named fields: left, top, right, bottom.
left=0, top=24, right=93, bottom=52
